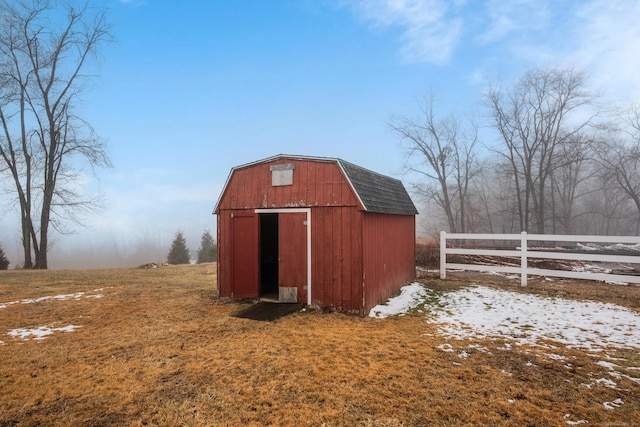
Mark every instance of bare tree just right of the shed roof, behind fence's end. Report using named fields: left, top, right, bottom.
left=389, top=95, right=478, bottom=232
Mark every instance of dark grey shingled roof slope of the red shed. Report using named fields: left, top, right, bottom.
left=336, top=159, right=418, bottom=215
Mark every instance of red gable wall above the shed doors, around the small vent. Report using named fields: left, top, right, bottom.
left=218, top=159, right=359, bottom=210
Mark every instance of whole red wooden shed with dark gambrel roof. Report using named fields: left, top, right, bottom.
left=214, top=155, right=418, bottom=314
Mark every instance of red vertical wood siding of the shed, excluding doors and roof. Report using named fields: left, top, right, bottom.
left=216, top=157, right=415, bottom=314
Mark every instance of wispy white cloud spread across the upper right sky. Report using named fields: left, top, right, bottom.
left=342, top=0, right=640, bottom=103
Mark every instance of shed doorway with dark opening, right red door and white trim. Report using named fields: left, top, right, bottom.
left=256, top=209, right=311, bottom=303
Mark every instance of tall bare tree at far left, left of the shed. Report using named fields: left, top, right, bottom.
left=0, top=0, right=110, bottom=268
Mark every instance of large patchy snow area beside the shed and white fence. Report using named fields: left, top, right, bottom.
left=369, top=283, right=640, bottom=349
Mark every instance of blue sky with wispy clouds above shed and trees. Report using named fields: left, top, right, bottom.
left=0, top=0, right=640, bottom=268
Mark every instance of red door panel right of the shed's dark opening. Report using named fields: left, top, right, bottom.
left=278, top=211, right=307, bottom=302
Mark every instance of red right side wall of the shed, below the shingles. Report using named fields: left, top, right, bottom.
left=362, top=213, right=416, bottom=311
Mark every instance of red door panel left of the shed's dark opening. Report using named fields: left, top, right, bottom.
left=231, top=213, right=259, bottom=298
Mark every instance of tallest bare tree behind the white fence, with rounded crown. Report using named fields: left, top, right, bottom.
left=486, top=68, right=595, bottom=233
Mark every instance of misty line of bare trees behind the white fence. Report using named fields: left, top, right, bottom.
left=396, top=68, right=640, bottom=235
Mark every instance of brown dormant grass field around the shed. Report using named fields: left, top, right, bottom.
left=0, top=264, right=640, bottom=426
